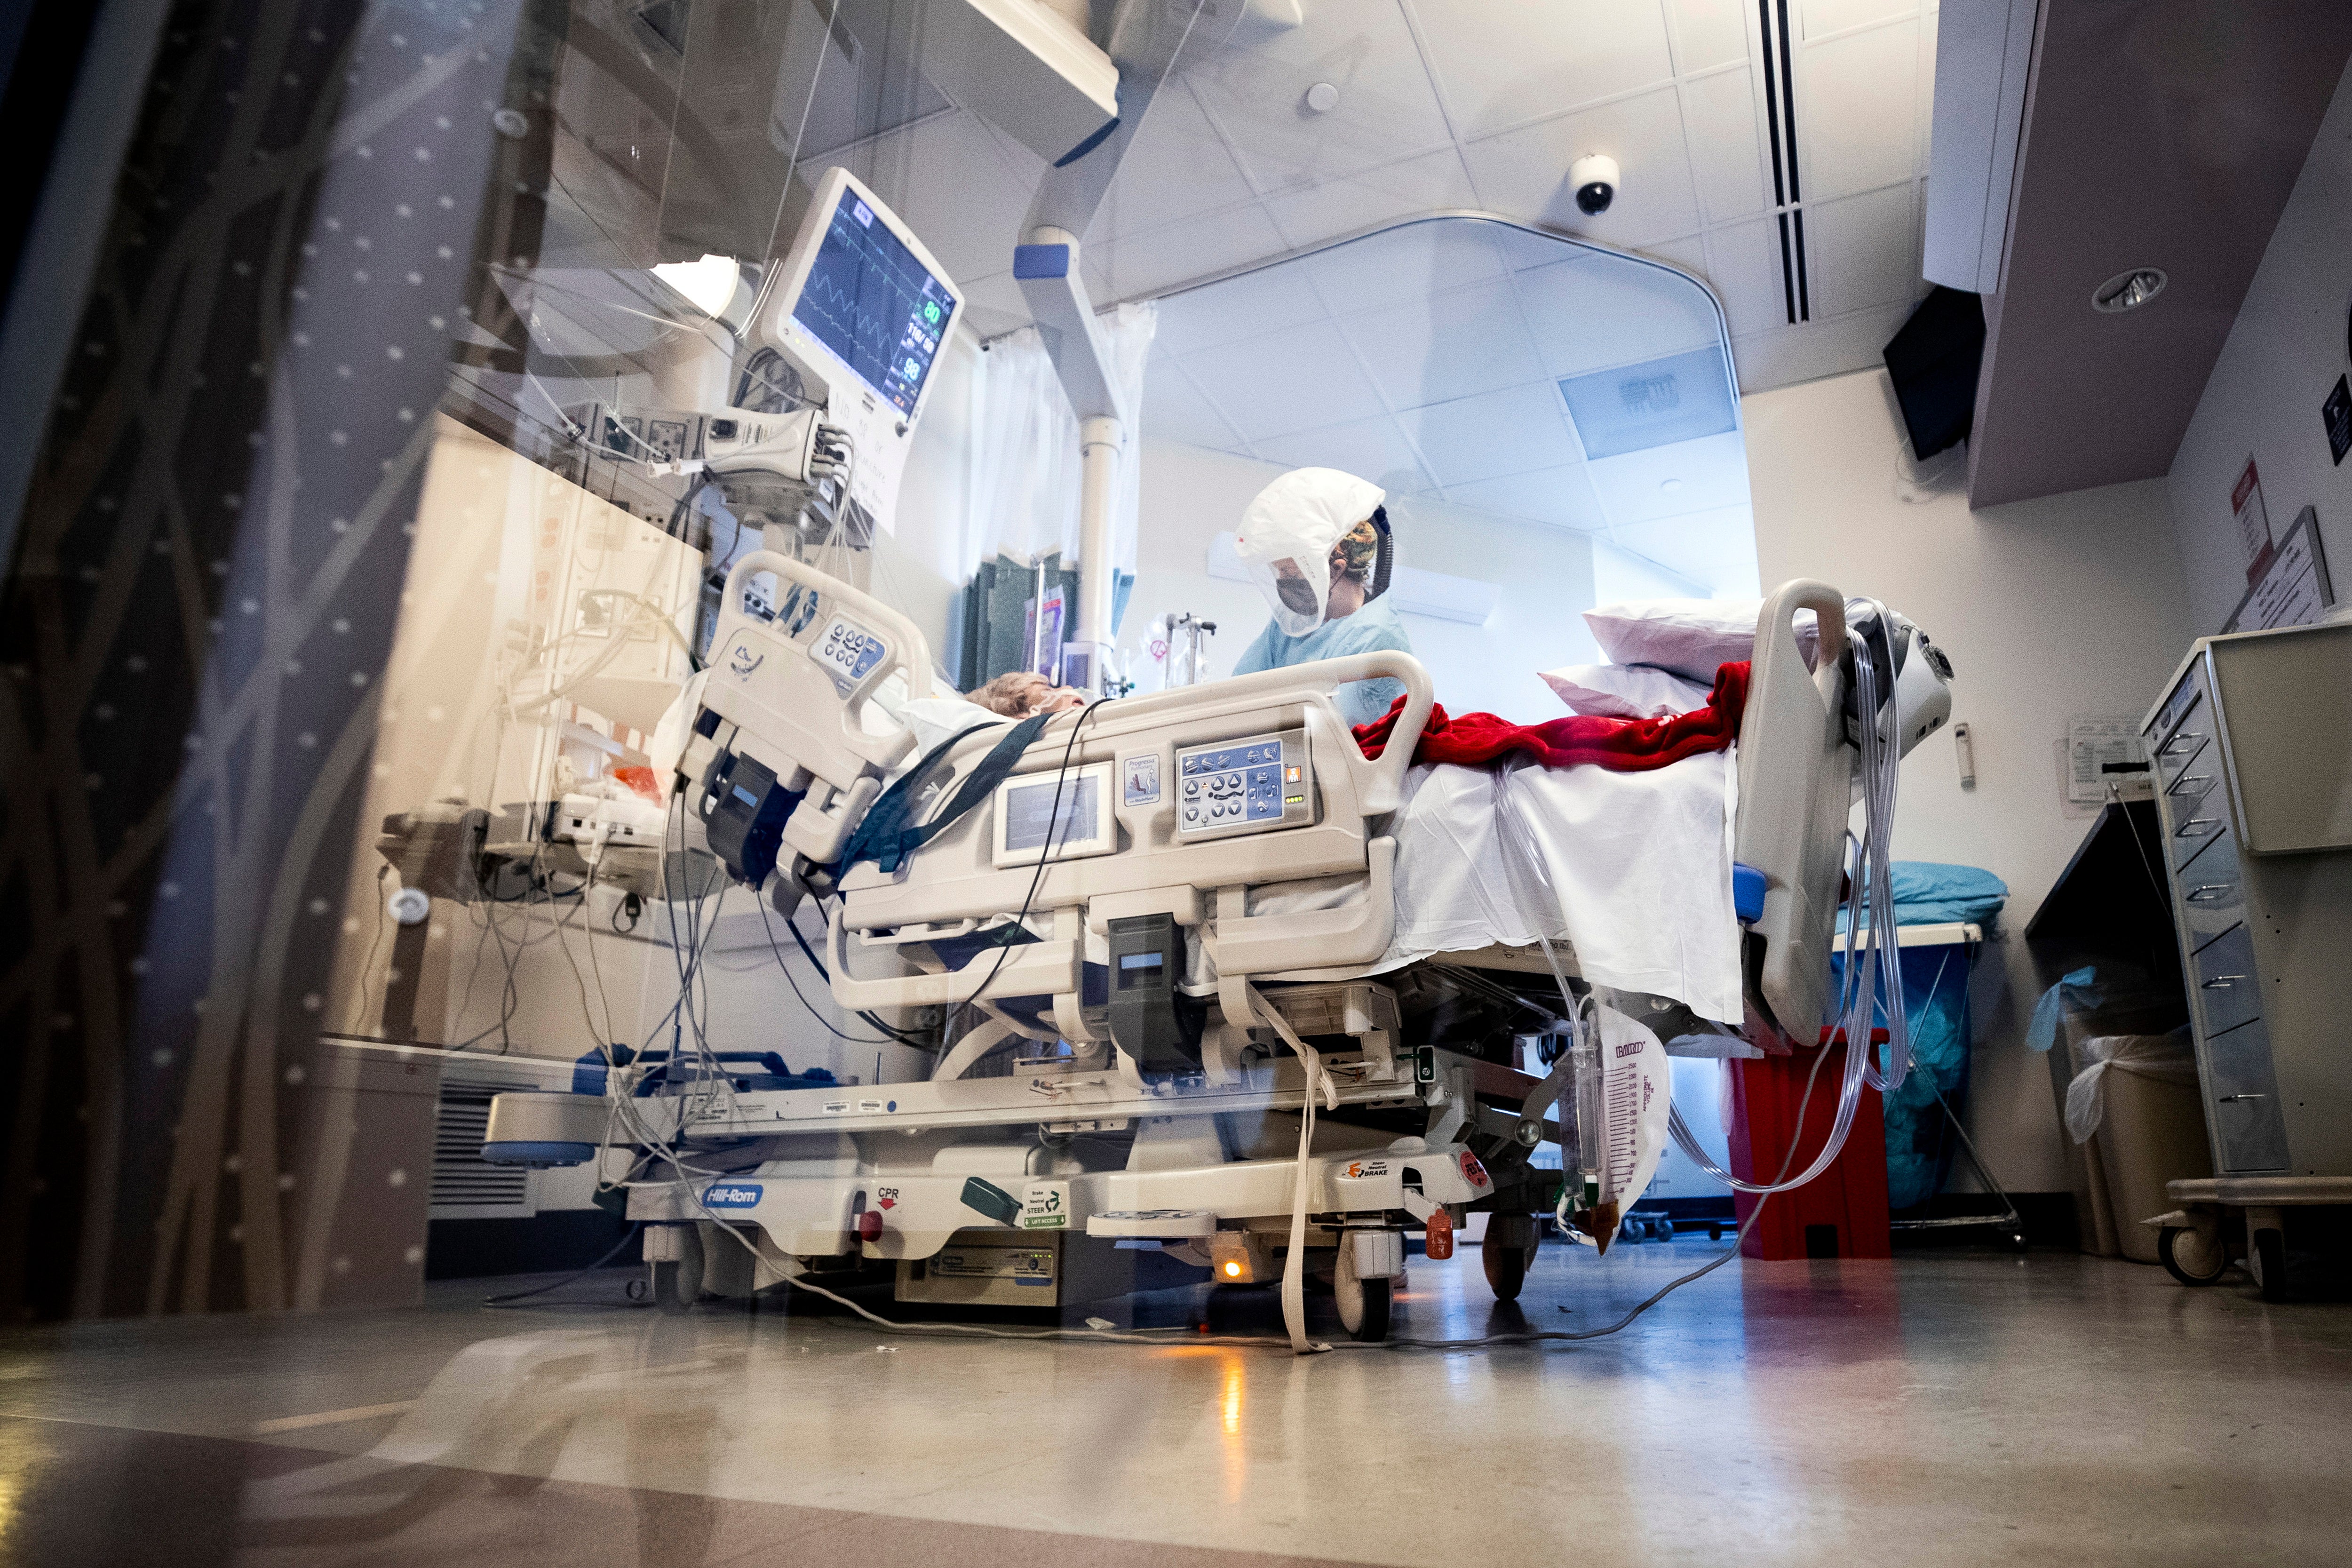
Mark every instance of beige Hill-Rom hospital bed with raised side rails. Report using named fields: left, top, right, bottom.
left=485, top=552, right=1856, bottom=1345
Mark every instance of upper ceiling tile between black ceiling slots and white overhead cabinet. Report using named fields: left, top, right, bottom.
left=1797, top=21, right=1926, bottom=202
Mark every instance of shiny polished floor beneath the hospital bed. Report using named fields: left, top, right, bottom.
left=0, top=1239, right=2352, bottom=1568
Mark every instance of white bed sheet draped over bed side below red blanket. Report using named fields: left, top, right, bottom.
left=1249, top=750, right=1740, bottom=1025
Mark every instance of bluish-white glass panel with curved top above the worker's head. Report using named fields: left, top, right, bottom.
left=1145, top=214, right=1757, bottom=597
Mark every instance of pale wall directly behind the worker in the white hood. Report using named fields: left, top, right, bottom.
left=1120, top=439, right=1599, bottom=724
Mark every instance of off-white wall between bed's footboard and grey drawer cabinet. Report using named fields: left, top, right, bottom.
left=1745, top=372, right=2192, bottom=1192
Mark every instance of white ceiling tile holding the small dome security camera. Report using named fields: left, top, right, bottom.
left=1463, top=87, right=1698, bottom=247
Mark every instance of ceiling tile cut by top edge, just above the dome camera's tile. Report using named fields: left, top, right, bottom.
left=1409, top=0, right=1675, bottom=141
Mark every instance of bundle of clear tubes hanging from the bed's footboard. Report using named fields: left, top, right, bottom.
left=1668, top=599, right=1910, bottom=1194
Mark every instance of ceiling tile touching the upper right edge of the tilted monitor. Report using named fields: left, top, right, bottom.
left=842, top=113, right=1030, bottom=280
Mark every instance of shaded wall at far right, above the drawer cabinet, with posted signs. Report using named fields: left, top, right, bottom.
left=2150, top=61, right=2352, bottom=637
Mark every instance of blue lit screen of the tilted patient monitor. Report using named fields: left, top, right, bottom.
left=793, top=191, right=955, bottom=416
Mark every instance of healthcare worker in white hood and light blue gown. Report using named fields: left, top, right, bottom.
left=1232, top=468, right=1414, bottom=724
